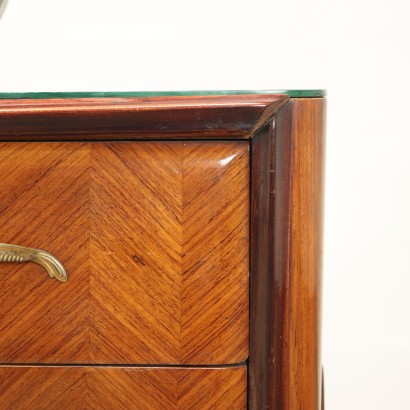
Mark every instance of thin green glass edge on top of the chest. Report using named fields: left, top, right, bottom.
left=0, top=90, right=326, bottom=100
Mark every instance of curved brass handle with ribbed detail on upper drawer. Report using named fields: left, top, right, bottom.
left=0, top=243, right=67, bottom=282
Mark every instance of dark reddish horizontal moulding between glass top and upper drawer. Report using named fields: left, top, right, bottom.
left=0, top=94, right=289, bottom=141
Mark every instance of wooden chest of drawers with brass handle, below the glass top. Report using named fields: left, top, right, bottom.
left=0, top=93, right=324, bottom=410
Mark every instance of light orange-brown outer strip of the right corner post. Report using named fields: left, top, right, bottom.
left=288, top=99, right=324, bottom=410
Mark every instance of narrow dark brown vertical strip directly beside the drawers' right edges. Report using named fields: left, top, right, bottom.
left=249, top=126, right=275, bottom=409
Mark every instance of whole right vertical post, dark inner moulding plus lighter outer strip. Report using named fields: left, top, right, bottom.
left=249, top=99, right=324, bottom=410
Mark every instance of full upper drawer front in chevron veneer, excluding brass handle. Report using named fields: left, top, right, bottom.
left=0, top=142, right=249, bottom=364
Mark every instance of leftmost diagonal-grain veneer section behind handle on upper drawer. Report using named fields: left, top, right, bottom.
left=0, top=143, right=90, bottom=363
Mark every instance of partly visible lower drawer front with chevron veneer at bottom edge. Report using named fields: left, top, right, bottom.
left=0, top=366, right=246, bottom=410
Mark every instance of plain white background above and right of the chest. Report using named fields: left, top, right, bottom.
left=0, top=0, right=410, bottom=410
